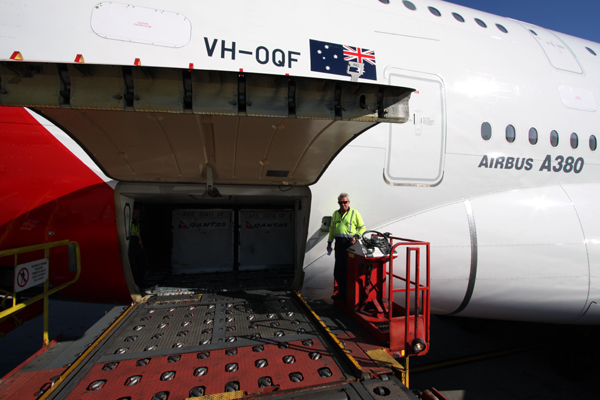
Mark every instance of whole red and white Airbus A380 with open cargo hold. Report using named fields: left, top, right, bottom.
left=0, top=0, right=600, bottom=324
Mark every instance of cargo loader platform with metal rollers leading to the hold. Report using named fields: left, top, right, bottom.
left=0, top=289, right=416, bottom=400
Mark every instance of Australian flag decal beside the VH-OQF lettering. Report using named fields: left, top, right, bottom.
left=310, top=39, right=377, bottom=80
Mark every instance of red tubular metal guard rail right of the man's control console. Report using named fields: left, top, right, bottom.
left=386, top=237, right=431, bottom=356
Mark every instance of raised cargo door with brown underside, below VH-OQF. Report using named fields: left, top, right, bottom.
left=0, top=62, right=412, bottom=185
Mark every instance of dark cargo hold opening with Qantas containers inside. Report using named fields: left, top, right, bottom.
left=115, top=182, right=310, bottom=294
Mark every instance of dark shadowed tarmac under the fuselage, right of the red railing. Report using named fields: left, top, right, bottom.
left=410, top=316, right=600, bottom=400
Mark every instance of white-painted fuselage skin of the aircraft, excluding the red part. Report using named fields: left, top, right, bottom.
left=0, top=0, right=600, bottom=324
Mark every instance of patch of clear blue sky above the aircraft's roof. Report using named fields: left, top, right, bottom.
left=448, top=0, right=600, bottom=43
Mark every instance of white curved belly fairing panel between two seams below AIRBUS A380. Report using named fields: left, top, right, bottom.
left=464, top=186, right=589, bottom=322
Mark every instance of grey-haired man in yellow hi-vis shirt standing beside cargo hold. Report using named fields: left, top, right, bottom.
left=327, top=193, right=365, bottom=300
